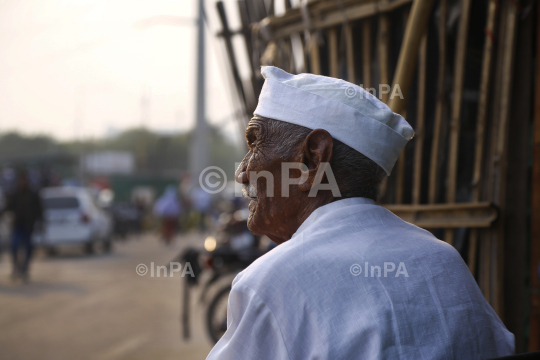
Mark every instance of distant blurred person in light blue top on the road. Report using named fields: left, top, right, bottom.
left=154, top=185, right=182, bottom=244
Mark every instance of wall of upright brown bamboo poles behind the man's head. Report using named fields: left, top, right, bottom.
left=235, top=0, right=520, bottom=316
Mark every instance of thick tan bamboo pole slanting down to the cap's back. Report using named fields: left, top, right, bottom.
left=388, top=0, right=433, bottom=114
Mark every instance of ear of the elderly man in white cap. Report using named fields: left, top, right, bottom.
left=298, top=129, right=334, bottom=191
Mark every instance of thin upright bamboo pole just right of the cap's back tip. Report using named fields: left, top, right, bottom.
left=412, top=35, right=427, bottom=204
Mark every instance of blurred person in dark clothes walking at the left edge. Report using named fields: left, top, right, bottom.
left=4, top=172, right=43, bottom=282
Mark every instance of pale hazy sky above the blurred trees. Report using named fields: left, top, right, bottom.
left=0, top=0, right=250, bottom=141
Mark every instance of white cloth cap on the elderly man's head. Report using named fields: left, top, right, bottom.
left=254, top=66, right=414, bottom=175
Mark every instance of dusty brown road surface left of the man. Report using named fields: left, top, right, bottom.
left=0, top=235, right=215, bottom=360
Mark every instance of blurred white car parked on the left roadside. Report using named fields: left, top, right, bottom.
left=37, top=187, right=113, bottom=253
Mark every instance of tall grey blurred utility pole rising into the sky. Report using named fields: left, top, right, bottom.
left=189, top=0, right=210, bottom=184
